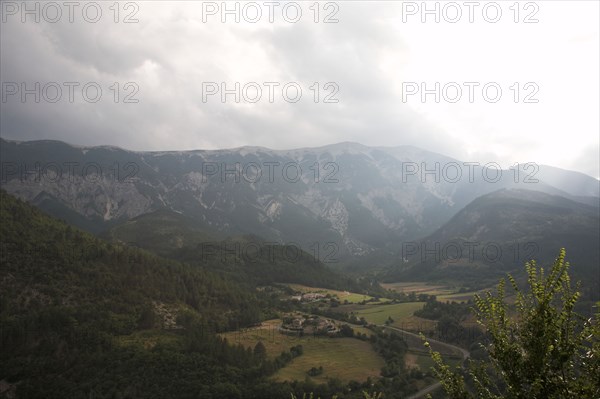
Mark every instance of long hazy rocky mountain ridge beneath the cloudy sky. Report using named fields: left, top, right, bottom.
left=1, top=140, right=600, bottom=268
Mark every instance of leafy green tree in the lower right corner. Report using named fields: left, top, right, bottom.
left=425, top=249, right=600, bottom=399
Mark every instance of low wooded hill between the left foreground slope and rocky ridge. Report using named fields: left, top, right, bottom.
left=105, top=209, right=385, bottom=295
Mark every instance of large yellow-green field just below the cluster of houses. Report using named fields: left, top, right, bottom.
left=222, top=320, right=385, bottom=383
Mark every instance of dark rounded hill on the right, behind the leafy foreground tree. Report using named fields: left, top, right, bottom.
left=387, top=189, right=600, bottom=300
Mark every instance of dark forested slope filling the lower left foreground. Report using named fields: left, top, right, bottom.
left=0, top=192, right=289, bottom=398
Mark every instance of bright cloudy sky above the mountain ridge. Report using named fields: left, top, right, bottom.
left=0, top=0, right=600, bottom=178
